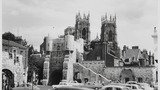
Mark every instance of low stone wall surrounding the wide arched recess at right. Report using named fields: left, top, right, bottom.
left=103, top=67, right=156, bottom=82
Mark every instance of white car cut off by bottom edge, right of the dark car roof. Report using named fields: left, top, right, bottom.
left=101, top=85, right=130, bottom=90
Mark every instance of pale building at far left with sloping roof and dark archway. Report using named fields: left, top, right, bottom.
left=2, top=39, right=28, bottom=90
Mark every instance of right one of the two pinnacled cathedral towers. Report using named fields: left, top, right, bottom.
left=101, top=14, right=118, bottom=56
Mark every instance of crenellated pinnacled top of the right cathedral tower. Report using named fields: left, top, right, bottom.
left=101, top=13, right=116, bottom=24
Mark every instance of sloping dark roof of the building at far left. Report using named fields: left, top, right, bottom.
left=2, top=39, right=27, bottom=49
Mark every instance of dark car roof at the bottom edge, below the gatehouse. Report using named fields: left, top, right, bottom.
left=50, top=86, right=94, bottom=90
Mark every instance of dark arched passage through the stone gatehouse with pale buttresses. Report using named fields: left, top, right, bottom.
left=49, top=70, right=62, bottom=85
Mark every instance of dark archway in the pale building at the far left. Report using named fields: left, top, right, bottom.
left=2, top=69, right=14, bottom=90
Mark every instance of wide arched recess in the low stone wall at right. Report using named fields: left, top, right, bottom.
left=120, top=69, right=135, bottom=83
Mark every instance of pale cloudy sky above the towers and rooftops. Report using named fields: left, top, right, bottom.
left=2, top=0, right=158, bottom=51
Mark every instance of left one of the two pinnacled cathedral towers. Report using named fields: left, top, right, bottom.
left=75, top=13, right=90, bottom=43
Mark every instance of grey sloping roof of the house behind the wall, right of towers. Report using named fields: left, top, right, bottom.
left=124, top=49, right=142, bottom=59
